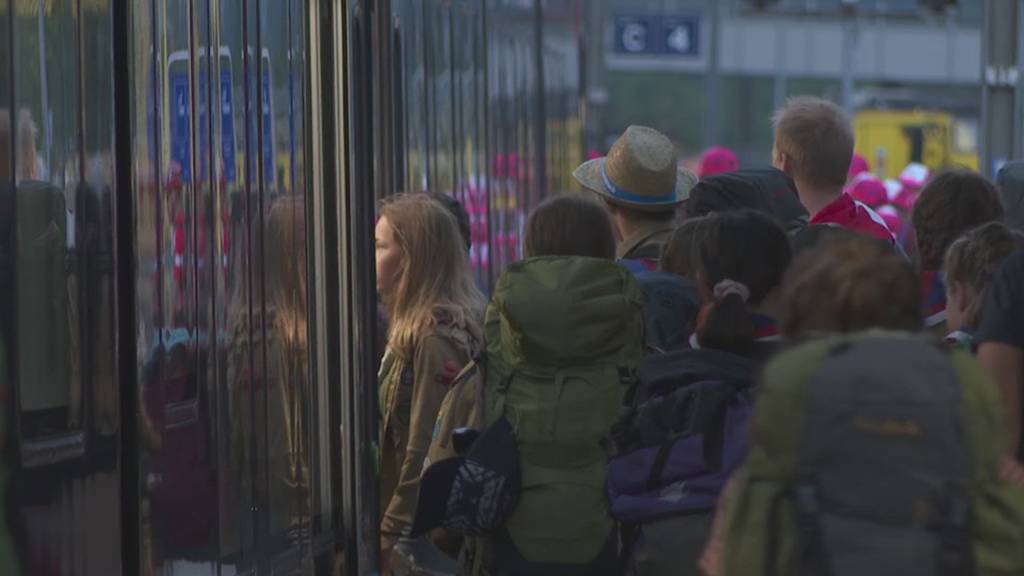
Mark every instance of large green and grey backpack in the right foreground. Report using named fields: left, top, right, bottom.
left=722, top=332, right=1024, bottom=576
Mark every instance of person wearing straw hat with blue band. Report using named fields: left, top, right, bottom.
left=572, top=126, right=697, bottom=272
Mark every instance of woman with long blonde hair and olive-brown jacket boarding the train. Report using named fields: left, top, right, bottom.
left=375, top=195, right=485, bottom=573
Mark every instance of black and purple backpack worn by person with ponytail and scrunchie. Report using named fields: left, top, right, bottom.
left=607, top=349, right=754, bottom=576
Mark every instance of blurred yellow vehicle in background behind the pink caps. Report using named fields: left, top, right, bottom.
left=853, top=109, right=978, bottom=178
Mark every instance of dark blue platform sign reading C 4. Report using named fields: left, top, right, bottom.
left=614, top=14, right=700, bottom=58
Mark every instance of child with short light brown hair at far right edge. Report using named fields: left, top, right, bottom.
left=943, top=222, right=1024, bottom=352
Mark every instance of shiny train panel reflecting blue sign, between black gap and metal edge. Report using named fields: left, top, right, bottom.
left=129, top=0, right=327, bottom=575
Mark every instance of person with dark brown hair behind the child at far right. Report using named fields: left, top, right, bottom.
left=911, top=169, right=1002, bottom=330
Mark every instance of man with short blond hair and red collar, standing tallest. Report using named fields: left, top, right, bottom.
left=772, top=96, right=895, bottom=243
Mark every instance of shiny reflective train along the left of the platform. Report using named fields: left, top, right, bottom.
left=0, top=0, right=587, bottom=576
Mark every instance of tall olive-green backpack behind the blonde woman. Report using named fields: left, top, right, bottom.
left=483, top=256, right=643, bottom=564
